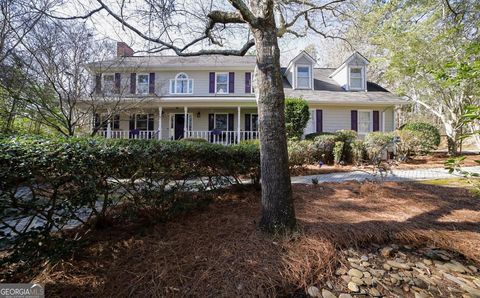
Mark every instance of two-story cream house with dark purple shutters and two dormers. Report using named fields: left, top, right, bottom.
left=88, top=43, right=404, bottom=144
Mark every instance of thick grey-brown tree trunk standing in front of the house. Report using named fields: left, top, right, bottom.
left=253, top=14, right=296, bottom=234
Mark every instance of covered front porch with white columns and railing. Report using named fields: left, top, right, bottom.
left=95, top=106, right=259, bottom=145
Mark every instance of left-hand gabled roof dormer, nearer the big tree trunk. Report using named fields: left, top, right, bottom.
left=284, top=51, right=316, bottom=90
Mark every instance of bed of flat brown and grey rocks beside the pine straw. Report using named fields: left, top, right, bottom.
left=307, top=244, right=480, bottom=298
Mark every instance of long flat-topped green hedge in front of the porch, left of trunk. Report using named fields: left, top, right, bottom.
left=0, top=136, right=260, bottom=265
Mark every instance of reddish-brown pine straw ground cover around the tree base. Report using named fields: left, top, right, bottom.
left=31, top=182, right=480, bottom=297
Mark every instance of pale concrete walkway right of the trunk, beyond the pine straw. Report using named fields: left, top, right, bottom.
left=292, top=166, right=480, bottom=184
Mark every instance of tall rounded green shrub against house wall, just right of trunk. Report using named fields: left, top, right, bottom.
left=285, top=98, right=310, bottom=139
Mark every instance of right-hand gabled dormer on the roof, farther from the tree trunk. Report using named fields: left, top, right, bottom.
left=330, top=52, right=370, bottom=91
